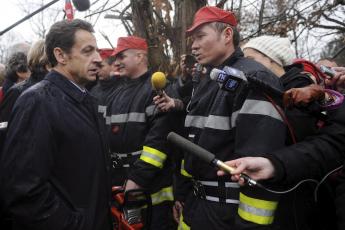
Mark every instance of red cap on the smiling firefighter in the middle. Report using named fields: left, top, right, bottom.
left=112, top=36, right=148, bottom=56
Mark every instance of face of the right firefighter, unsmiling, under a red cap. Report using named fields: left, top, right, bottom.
left=192, top=24, right=228, bottom=66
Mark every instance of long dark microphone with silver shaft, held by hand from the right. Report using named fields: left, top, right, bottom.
left=167, top=132, right=260, bottom=186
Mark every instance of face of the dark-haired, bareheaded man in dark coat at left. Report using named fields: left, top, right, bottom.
left=65, top=30, right=102, bottom=85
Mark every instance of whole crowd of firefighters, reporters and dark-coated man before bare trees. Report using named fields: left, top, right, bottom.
left=0, top=6, right=345, bottom=230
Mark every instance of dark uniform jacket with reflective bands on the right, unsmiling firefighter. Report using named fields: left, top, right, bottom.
left=180, top=48, right=286, bottom=229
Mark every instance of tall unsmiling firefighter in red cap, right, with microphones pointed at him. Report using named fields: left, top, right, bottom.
left=176, top=6, right=286, bottom=230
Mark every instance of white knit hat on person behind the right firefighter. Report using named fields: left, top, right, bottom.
left=242, top=35, right=295, bottom=66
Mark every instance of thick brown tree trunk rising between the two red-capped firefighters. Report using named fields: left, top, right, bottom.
left=131, top=0, right=207, bottom=72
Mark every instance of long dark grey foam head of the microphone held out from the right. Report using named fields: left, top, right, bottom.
left=167, top=132, right=215, bottom=164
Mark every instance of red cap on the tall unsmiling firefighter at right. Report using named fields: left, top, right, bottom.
left=187, top=6, right=237, bottom=35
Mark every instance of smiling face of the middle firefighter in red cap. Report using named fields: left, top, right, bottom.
left=115, top=49, right=140, bottom=78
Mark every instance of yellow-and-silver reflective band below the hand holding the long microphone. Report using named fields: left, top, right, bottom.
left=238, top=193, right=278, bottom=225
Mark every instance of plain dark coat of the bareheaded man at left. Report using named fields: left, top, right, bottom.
left=0, top=71, right=110, bottom=230
